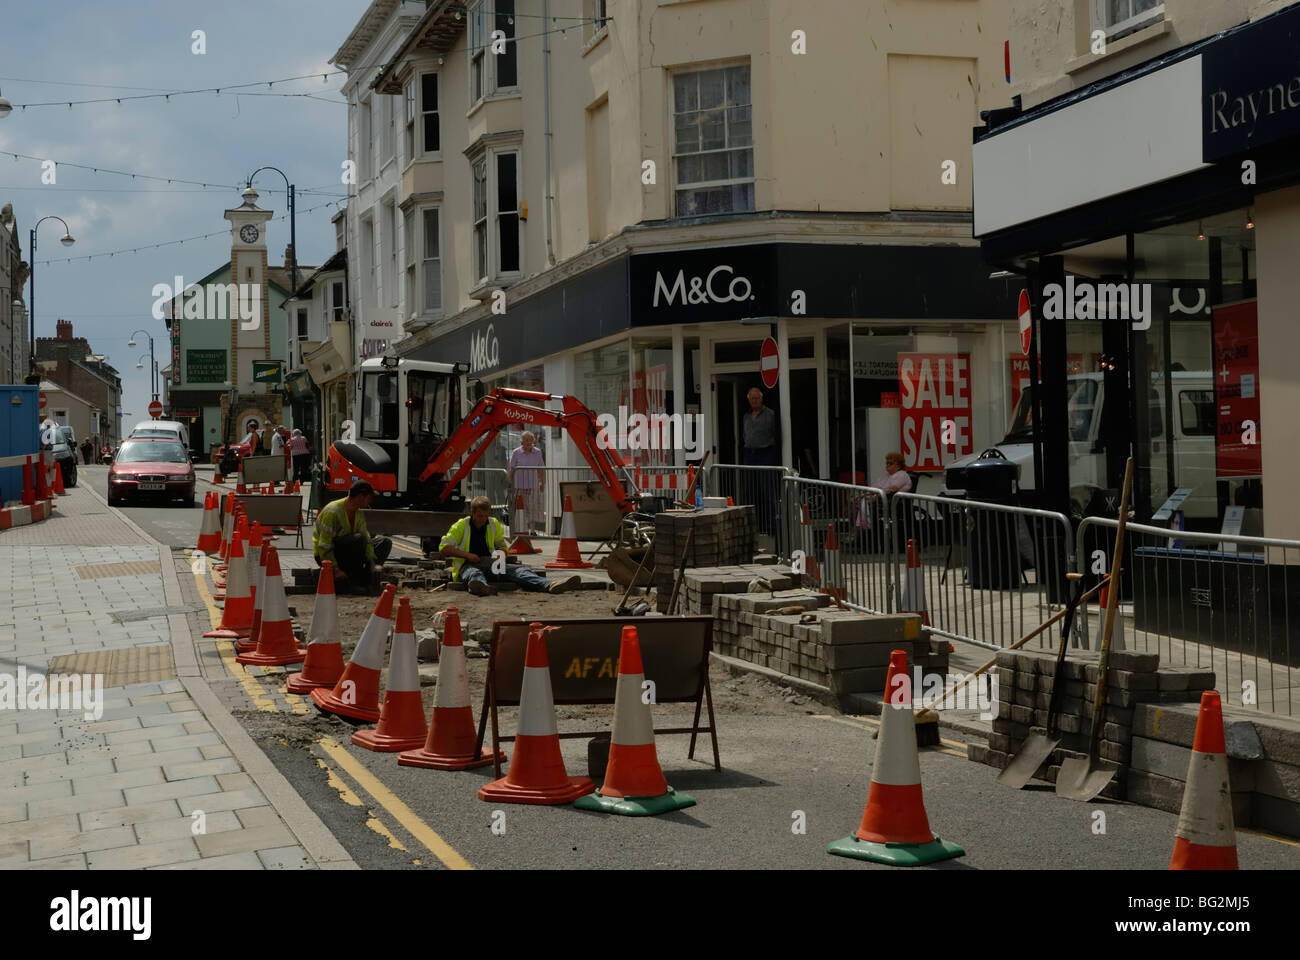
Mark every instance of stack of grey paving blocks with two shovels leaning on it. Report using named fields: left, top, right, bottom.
left=971, top=650, right=1214, bottom=800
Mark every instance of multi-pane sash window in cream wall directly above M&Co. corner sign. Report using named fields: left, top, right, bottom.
left=672, top=64, right=754, bottom=217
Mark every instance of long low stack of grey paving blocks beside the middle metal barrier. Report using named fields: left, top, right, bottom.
left=712, top=591, right=948, bottom=709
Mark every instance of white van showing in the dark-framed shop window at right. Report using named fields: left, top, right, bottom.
left=945, top=371, right=1218, bottom=518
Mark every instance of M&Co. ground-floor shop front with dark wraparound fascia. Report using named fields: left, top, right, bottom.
left=408, top=242, right=1018, bottom=488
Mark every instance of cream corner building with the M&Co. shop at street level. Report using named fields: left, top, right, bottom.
left=335, top=0, right=1019, bottom=494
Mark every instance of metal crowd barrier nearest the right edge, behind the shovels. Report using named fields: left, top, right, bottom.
left=1079, top=516, right=1300, bottom=715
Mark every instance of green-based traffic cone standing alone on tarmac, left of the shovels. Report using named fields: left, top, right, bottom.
left=826, top=650, right=966, bottom=866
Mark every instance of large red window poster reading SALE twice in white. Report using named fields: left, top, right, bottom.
left=898, top=354, right=974, bottom=470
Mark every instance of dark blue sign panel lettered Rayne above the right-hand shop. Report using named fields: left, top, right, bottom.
left=1201, top=7, right=1300, bottom=163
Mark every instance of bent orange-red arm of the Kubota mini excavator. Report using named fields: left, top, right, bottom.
left=420, top=386, right=641, bottom=514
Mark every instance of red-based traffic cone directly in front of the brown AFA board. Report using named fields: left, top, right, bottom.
left=478, top=623, right=595, bottom=804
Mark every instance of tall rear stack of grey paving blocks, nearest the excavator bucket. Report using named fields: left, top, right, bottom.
left=654, top=506, right=754, bottom=613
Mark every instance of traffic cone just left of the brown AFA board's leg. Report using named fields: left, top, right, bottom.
left=398, top=606, right=506, bottom=770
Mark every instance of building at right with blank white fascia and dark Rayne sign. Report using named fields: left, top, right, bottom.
left=974, top=0, right=1300, bottom=539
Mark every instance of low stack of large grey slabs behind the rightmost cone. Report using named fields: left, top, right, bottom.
left=1127, top=697, right=1300, bottom=836
